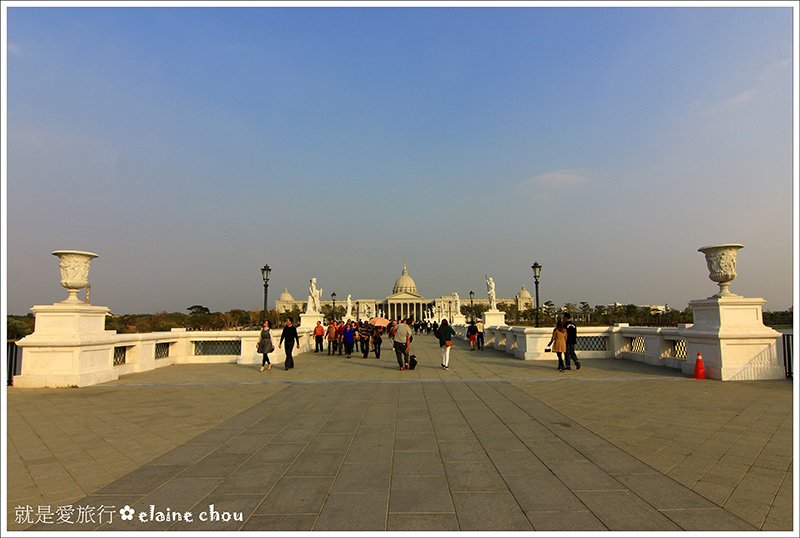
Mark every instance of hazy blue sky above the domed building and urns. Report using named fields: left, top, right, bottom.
left=3, top=4, right=796, bottom=314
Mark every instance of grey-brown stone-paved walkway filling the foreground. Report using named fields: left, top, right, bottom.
left=7, top=336, right=793, bottom=532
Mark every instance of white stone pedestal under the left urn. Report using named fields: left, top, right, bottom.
left=14, top=302, right=119, bottom=387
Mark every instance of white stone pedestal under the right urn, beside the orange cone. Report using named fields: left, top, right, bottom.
left=680, top=294, right=786, bottom=382
